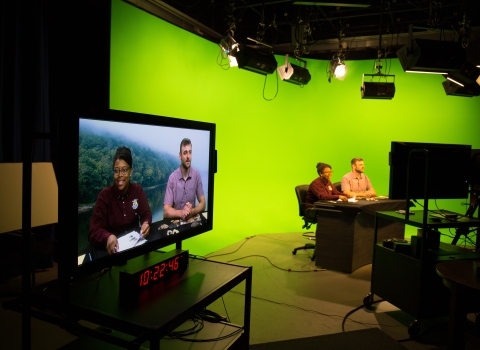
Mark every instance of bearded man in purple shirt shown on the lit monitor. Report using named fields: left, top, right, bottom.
left=163, top=138, right=205, bottom=220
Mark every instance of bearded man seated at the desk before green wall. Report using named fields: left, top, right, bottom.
left=342, top=158, right=377, bottom=198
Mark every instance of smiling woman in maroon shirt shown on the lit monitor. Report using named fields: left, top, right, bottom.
left=88, top=147, right=152, bottom=255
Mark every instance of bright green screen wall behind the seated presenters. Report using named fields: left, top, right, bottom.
left=110, top=0, right=480, bottom=254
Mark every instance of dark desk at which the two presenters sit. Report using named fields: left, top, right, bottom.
left=313, top=199, right=405, bottom=273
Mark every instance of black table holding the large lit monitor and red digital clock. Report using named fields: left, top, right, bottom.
left=6, top=252, right=252, bottom=349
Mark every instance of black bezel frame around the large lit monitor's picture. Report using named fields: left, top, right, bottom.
left=58, top=109, right=217, bottom=280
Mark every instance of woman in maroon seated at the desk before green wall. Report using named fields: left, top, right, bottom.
left=305, top=163, right=348, bottom=209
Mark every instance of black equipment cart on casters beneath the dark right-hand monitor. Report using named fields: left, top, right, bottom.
left=364, top=210, right=480, bottom=336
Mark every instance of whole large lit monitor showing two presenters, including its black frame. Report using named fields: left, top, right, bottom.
left=59, top=110, right=216, bottom=276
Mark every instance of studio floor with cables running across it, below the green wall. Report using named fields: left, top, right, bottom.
left=0, top=233, right=480, bottom=350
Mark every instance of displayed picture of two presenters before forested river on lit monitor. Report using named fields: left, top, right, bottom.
left=77, top=119, right=211, bottom=265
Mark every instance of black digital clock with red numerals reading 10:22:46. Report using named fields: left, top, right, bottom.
left=120, top=249, right=188, bottom=293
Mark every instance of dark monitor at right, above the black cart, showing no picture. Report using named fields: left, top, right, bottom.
left=389, top=141, right=471, bottom=199
